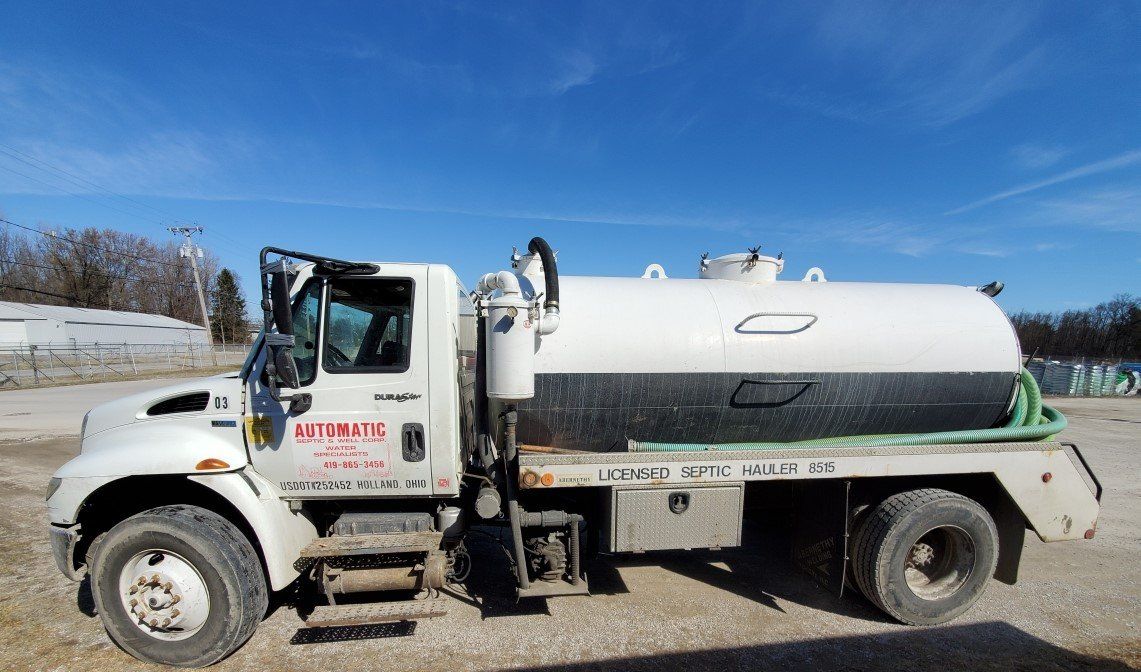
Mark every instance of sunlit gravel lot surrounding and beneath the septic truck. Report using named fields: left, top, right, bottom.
left=0, top=383, right=1141, bottom=672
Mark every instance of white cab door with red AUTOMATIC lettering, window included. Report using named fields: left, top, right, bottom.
left=246, top=265, right=431, bottom=499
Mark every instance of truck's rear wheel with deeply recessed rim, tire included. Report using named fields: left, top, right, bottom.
left=851, top=488, right=998, bottom=625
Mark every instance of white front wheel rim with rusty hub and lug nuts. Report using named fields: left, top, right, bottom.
left=119, top=549, right=210, bottom=641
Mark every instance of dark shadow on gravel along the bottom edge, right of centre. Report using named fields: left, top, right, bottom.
left=513, top=622, right=1136, bottom=672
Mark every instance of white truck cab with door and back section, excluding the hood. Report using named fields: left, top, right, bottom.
left=242, top=258, right=476, bottom=500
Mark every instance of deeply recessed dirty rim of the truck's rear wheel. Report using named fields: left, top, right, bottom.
left=904, top=525, right=974, bottom=600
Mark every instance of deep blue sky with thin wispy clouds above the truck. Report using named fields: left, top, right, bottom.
left=0, top=2, right=1141, bottom=310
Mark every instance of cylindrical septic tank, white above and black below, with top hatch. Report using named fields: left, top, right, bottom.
left=508, top=252, right=1021, bottom=451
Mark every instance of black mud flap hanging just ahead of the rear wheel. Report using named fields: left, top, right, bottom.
left=792, top=480, right=851, bottom=597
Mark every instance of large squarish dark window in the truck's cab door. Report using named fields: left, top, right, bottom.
left=322, top=277, right=412, bottom=373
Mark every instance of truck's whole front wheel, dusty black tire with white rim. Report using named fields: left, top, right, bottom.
left=91, top=505, right=269, bottom=667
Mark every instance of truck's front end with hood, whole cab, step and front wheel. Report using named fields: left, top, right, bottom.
left=48, top=251, right=476, bottom=665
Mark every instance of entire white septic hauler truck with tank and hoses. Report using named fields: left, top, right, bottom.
left=47, top=238, right=1101, bottom=666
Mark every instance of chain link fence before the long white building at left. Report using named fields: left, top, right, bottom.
left=0, top=343, right=250, bottom=389
